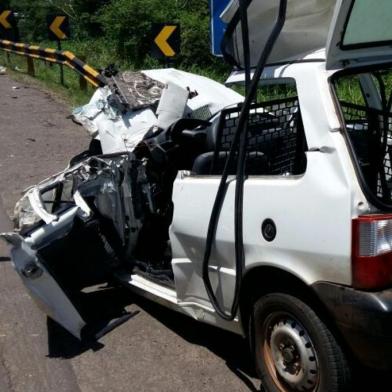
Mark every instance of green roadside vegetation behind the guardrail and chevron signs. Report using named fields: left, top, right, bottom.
left=0, top=0, right=230, bottom=105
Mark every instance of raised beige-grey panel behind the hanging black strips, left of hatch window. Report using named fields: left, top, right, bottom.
left=221, top=0, right=336, bottom=68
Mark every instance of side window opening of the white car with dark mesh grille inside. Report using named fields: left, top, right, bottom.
left=193, top=79, right=307, bottom=176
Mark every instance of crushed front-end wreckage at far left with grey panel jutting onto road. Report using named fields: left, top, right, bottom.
left=0, top=154, right=147, bottom=339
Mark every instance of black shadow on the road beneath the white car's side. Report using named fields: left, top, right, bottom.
left=47, top=288, right=260, bottom=391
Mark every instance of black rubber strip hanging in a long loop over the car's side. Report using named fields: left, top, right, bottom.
left=203, top=0, right=287, bottom=321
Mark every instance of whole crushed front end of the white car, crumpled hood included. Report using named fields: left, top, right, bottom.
left=9, top=67, right=242, bottom=289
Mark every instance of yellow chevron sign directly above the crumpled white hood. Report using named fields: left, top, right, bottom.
left=153, top=24, right=181, bottom=57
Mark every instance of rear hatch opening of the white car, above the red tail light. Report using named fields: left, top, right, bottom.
left=334, top=68, right=392, bottom=208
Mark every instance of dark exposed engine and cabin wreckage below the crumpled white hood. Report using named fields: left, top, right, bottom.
left=16, top=115, right=217, bottom=289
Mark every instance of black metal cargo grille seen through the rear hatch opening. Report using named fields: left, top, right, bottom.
left=341, top=102, right=392, bottom=203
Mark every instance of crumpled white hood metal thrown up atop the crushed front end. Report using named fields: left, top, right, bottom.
left=73, top=69, right=243, bottom=154
